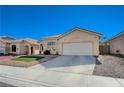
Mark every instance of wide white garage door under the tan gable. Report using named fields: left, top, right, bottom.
left=63, top=42, right=93, bottom=55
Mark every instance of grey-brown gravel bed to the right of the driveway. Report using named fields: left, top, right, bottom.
left=93, top=55, right=124, bottom=78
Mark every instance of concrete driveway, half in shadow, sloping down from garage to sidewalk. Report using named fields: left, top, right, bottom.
left=31, top=55, right=96, bottom=74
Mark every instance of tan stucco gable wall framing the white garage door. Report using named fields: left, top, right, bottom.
left=58, top=30, right=99, bottom=56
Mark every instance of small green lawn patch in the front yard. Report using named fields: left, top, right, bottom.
left=12, top=56, right=43, bottom=62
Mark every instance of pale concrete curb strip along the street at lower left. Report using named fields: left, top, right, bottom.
left=0, top=75, right=58, bottom=87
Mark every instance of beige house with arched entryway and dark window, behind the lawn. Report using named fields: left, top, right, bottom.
left=10, top=39, right=40, bottom=55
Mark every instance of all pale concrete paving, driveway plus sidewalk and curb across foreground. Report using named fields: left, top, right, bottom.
left=0, top=56, right=124, bottom=87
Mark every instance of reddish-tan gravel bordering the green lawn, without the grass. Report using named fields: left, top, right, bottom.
left=0, top=55, right=57, bottom=67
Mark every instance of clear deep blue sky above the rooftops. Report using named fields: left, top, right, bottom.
left=0, top=5, right=124, bottom=39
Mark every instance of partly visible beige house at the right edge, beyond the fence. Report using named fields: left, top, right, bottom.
left=109, top=31, right=124, bottom=55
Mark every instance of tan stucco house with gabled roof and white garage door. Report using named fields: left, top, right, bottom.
left=39, top=28, right=101, bottom=56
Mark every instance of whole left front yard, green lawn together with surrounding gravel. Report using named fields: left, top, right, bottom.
left=0, top=55, right=57, bottom=67
